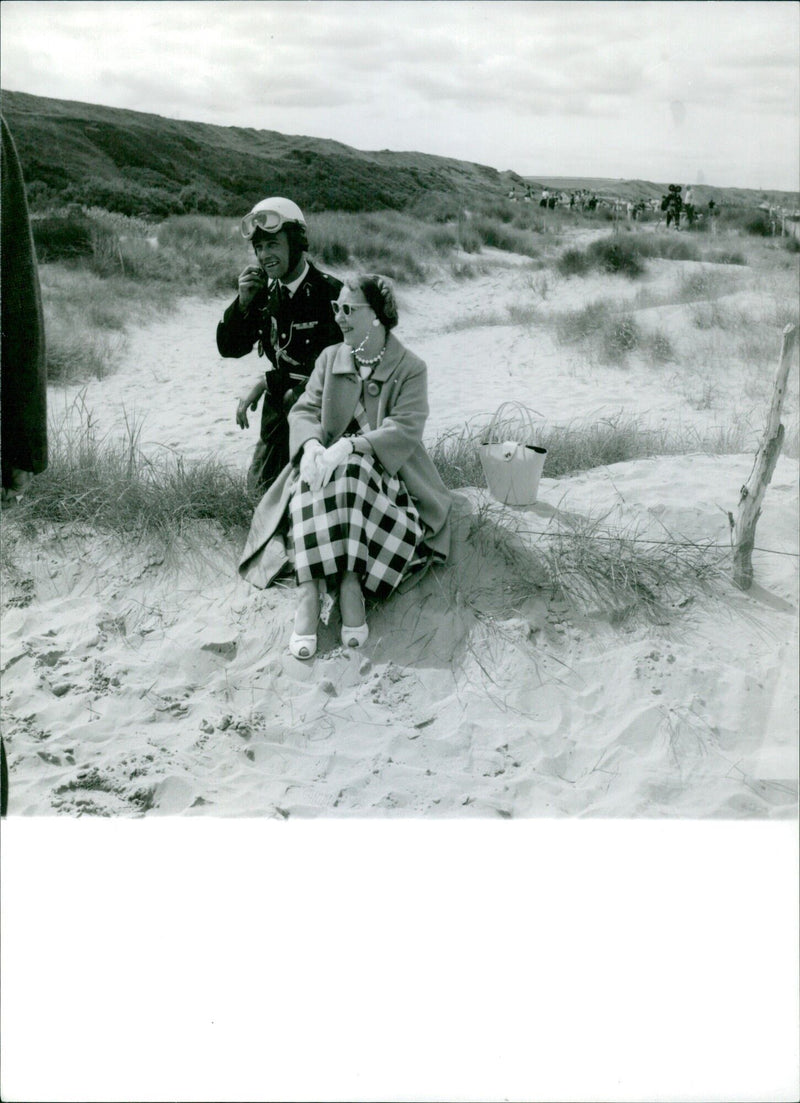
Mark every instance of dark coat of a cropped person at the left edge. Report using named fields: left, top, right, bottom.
left=0, top=119, right=47, bottom=488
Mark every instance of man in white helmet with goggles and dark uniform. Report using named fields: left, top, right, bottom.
left=216, top=196, right=342, bottom=493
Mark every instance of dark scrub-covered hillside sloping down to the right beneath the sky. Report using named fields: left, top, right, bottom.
left=2, top=92, right=521, bottom=215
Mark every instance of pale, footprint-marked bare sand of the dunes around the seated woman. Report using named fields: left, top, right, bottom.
left=2, top=248, right=798, bottom=817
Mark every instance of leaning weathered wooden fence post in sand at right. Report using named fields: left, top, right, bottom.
left=734, top=325, right=797, bottom=590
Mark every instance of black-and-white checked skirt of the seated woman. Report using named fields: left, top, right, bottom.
left=289, top=445, right=424, bottom=597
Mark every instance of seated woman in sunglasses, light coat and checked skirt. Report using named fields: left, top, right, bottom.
left=233, top=275, right=452, bottom=658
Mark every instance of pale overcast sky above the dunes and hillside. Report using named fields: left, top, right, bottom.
left=0, top=0, right=800, bottom=190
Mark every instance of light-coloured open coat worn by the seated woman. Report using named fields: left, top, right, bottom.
left=239, top=334, right=452, bottom=588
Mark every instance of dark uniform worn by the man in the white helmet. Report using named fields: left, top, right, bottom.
left=216, top=264, right=342, bottom=489
